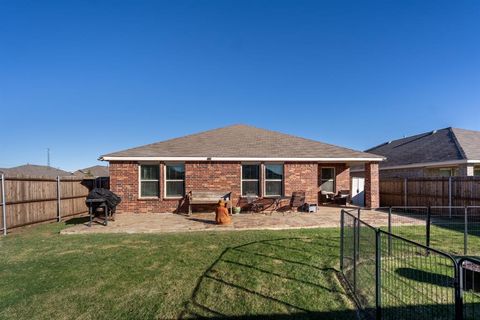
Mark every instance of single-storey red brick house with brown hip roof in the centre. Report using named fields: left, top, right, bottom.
left=100, top=125, right=383, bottom=212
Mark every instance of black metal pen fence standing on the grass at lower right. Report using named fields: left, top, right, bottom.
left=340, top=210, right=480, bottom=319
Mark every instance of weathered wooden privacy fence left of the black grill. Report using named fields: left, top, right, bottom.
left=0, top=175, right=88, bottom=234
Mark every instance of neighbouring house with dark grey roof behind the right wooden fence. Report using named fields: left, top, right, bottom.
left=352, top=127, right=480, bottom=178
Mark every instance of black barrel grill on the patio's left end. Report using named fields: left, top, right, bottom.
left=85, top=188, right=122, bottom=227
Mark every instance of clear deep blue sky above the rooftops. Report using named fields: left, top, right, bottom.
left=0, top=0, right=480, bottom=170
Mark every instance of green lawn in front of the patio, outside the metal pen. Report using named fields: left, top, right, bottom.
left=0, top=220, right=355, bottom=319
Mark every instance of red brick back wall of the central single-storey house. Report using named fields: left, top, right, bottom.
left=110, top=161, right=350, bottom=213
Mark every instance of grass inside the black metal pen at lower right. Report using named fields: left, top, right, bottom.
left=345, top=221, right=480, bottom=320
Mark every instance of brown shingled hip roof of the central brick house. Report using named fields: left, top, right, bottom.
left=100, top=125, right=383, bottom=161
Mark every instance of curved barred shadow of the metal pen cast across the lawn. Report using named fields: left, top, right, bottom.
left=179, top=237, right=356, bottom=319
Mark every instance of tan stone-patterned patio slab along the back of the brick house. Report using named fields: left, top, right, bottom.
left=61, top=207, right=420, bottom=234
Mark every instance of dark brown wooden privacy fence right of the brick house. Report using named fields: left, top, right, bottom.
left=380, top=177, right=480, bottom=206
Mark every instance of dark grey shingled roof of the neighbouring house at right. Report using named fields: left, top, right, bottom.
left=367, top=128, right=480, bottom=167
